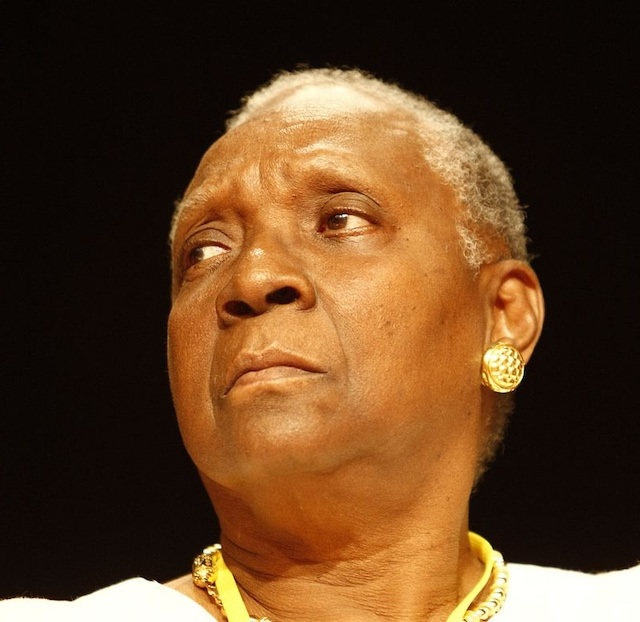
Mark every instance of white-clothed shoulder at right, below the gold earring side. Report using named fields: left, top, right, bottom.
left=500, top=564, right=640, bottom=622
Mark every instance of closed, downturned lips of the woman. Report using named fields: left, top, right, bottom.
left=222, top=349, right=326, bottom=397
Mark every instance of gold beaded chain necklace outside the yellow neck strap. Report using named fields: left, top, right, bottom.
left=191, top=544, right=509, bottom=622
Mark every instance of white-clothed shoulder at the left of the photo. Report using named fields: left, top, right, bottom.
left=0, top=578, right=214, bottom=622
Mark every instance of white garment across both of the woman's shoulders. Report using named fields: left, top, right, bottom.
left=0, top=564, right=640, bottom=622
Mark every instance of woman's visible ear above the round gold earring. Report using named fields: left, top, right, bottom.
left=479, top=259, right=544, bottom=363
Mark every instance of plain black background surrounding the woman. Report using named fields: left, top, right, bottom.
left=0, top=1, right=640, bottom=598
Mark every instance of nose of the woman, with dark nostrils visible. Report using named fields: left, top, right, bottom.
left=216, top=239, right=316, bottom=325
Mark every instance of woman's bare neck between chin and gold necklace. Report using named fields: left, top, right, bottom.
left=200, top=460, right=482, bottom=622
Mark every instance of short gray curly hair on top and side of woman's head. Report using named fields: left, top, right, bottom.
left=226, top=68, right=528, bottom=269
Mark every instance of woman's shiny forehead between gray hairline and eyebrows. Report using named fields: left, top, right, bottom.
left=178, top=105, right=426, bottom=222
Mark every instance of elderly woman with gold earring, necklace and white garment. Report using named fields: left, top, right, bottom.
left=0, top=69, right=640, bottom=622
